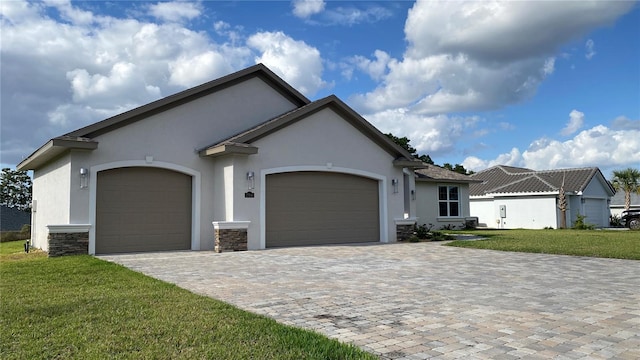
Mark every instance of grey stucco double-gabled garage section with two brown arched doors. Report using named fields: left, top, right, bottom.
left=18, top=64, right=422, bottom=255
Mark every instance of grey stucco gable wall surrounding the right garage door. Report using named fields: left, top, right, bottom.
left=234, top=108, right=404, bottom=249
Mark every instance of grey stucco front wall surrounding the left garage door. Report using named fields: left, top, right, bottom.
left=61, top=78, right=295, bottom=250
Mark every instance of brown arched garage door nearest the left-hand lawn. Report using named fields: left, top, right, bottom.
left=96, top=167, right=191, bottom=254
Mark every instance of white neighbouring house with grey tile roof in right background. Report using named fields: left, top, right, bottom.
left=469, top=165, right=615, bottom=229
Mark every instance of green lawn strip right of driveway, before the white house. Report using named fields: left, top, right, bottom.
left=448, top=229, right=640, bottom=260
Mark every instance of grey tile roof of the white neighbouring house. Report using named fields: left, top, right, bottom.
left=469, top=165, right=613, bottom=196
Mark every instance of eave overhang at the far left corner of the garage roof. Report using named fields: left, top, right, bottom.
left=16, top=136, right=98, bottom=170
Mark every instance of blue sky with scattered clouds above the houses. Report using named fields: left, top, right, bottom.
left=0, top=0, right=640, bottom=179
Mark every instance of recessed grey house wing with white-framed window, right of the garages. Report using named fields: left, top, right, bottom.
left=416, top=165, right=479, bottom=229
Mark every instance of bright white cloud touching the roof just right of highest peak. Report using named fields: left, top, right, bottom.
left=247, top=31, right=327, bottom=95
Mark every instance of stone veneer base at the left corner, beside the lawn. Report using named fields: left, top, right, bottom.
left=47, top=225, right=89, bottom=257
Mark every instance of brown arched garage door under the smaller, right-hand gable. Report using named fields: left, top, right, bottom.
left=266, top=171, right=380, bottom=247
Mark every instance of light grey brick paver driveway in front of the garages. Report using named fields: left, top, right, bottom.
left=101, top=243, right=640, bottom=359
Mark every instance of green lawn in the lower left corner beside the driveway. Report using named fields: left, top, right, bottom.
left=0, top=241, right=376, bottom=360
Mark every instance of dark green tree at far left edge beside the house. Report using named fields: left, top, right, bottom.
left=0, top=168, right=32, bottom=212
